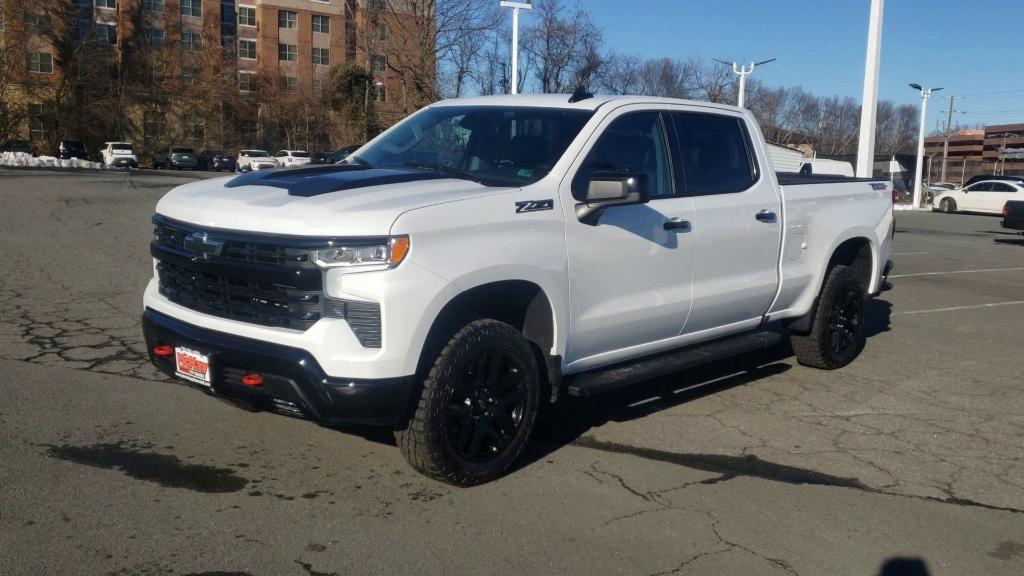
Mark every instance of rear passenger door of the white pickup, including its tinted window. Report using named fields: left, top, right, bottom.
left=672, top=110, right=782, bottom=334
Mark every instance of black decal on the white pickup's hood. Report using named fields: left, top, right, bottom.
left=224, top=165, right=447, bottom=198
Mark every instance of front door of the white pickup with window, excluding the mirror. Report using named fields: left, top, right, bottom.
left=561, top=107, right=693, bottom=370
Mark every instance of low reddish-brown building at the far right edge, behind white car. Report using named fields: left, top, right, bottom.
left=925, top=124, right=1024, bottom=183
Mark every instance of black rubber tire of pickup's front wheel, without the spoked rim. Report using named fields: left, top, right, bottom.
left=395, top=320, right=541, bottom=486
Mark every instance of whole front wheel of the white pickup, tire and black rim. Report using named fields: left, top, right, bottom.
left=395, top=320, right=541, bottom=486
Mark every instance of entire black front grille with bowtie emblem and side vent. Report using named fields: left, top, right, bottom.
left=151, top=215, right=381, bottom=342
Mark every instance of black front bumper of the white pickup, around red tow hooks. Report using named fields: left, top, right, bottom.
left=142, top=308, right=417, bottom=427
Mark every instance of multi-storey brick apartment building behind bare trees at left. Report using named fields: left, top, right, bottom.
left=0, top=0, right=419, bottom=156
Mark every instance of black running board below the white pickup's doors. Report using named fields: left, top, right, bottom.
left=565, top=330, right=782, bottom=397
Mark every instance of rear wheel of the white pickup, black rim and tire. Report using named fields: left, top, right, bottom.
left=790, top=265, right=866, bottom=370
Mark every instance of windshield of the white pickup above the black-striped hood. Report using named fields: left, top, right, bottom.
left=349, top=106, right=593, bottom=186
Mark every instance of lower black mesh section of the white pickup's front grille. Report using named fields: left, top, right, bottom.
left=157, top=261, right=324, bottom=330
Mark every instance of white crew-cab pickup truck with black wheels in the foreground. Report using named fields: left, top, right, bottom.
left=143, top=93, right=894, bottom=485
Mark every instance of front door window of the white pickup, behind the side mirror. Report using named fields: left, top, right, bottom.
left=572, top=112, right=675, bottom=200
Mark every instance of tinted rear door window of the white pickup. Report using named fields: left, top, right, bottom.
left=672, top=112, right=758, bottom=196
